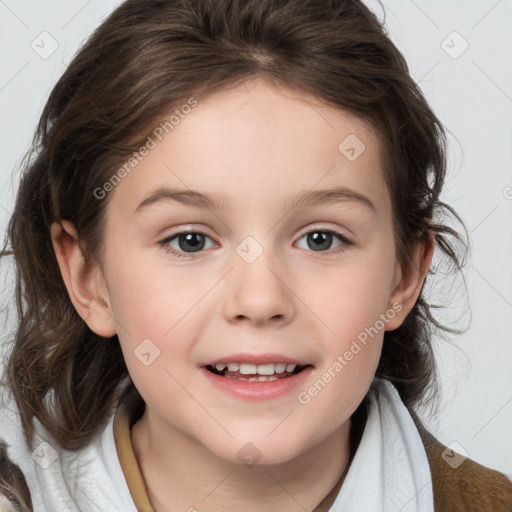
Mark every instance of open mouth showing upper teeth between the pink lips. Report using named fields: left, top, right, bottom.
left=204, top=363, right=313, bottom=382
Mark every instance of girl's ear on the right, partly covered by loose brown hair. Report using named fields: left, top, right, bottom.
left=386, top=232, right=435, bottom=331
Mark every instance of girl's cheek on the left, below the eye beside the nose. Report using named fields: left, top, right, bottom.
left=105, top=254, right=216, bottom=398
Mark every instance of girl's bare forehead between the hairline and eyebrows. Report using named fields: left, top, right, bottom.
left=107, top=80, right=389, bottom=219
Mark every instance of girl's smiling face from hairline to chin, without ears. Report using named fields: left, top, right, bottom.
left=88, top=81, right=410, bottom=464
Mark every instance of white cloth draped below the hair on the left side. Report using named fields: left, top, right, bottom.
left=0, top=386, right=135, bottom=512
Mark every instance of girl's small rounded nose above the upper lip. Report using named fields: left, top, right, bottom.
left=223, top=245, right=295, bottom=325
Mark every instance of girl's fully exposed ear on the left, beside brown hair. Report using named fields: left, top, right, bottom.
left=51, top=220, right=117, bottom=337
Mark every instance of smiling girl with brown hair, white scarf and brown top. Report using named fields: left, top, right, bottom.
left=2, top=0, right=512, bottom=512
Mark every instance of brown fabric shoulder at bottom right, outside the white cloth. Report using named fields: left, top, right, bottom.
left=409, top=411, right=512, bottom=512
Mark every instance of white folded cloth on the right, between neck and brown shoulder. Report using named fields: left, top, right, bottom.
left=330, top=378, right=434, bottom=512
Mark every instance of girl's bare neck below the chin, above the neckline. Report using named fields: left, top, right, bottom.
left=131, top=410, right=354, bottom=512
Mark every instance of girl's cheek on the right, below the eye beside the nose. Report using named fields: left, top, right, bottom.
left=304, top=239, right=395, bottom=384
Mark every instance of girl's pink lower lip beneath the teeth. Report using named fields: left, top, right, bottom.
left=200, top=366, right=313, bottom=400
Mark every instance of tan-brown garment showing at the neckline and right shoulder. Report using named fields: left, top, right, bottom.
left=114, top=406, right=512, bottom=512
